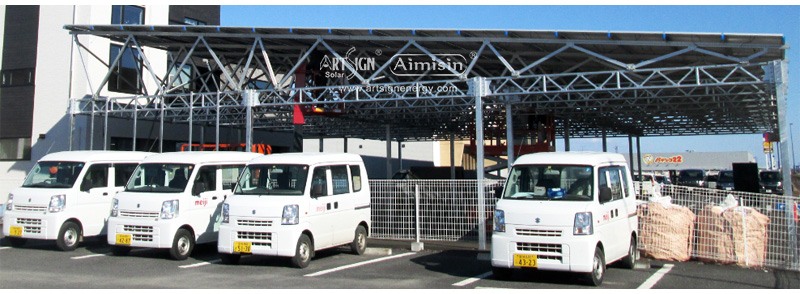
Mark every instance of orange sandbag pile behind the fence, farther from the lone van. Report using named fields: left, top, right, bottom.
left=697, top=205, right=770, bottom=267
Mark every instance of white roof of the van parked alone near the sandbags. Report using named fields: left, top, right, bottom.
left=514, top=151, right=627, bottom=165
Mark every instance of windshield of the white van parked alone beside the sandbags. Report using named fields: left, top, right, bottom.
left=503, top=165, right=594, bottom=201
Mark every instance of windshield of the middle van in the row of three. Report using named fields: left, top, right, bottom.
left=125, top=163, right=194, bottom=193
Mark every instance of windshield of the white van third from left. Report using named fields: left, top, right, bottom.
left=233, top=164, right=308, bottom=196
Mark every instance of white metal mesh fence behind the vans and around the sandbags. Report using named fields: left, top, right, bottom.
left=370, top=180, right=800, bottom=270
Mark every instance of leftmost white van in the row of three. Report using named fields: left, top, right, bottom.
left=3, top=151, right=153, bottom=251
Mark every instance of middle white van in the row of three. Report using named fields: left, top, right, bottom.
left=107, top=151, right=261, bottom=260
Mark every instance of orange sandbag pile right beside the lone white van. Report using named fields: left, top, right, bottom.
left=638, top=202, right=695, bottom=261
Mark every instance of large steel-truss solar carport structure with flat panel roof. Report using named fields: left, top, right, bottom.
left=65, top=25, right=790, bottom=186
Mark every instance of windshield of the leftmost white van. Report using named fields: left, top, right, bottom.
left=22, top=161, right=85, bottom=188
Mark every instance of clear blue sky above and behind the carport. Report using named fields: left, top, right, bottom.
left=221, top=5, right=800, bottom=167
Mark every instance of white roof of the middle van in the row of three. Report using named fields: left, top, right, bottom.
left=142, top=151, right=262, bottom=164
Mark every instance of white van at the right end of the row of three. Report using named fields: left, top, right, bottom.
left=217, top=153, right=371, bottom=268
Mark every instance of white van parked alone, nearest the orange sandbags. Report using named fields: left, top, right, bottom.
left=491, top=152, right=638, bottom=285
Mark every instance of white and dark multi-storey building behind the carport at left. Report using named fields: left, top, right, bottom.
left=0, top=5, right=220, bottom=207
